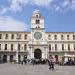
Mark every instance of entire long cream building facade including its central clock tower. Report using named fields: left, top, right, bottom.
left=0, top=10, right=75, bottom=62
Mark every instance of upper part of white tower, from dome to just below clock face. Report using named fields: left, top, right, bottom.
left=31, top=10, right=45, bottom=43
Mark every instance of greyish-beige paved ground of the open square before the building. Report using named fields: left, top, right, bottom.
left=0, top=63, right=75, bottom=75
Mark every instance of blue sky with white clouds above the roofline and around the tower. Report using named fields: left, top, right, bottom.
left=0, top=0, right=75, bottom=32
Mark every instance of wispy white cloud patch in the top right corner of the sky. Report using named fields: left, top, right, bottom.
left=53, top=0, right=75, bottom=12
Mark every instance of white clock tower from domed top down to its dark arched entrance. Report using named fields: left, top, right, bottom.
left=29, top=10, right=47, bottom=59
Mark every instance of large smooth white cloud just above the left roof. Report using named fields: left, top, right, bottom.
left=0, top=16, right=28, bottom=31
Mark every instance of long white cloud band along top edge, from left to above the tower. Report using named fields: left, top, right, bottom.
left=1, top=0, right=53, bottom=14
